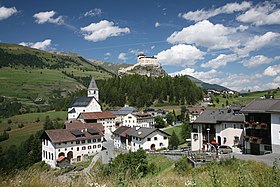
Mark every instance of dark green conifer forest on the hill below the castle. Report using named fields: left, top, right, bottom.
left=97, top=75, right=203, bottom=107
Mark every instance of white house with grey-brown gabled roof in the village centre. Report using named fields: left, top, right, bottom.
left=113, top=126, right=169, bottom=151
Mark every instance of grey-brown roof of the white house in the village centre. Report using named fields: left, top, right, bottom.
left=127, top=127, right=170, bottom=138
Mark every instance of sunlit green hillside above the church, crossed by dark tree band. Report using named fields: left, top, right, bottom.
left=0, top=43, right=112, bottom=102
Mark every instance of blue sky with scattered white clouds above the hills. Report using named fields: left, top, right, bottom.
left=0, top=0, right=280, bottom=91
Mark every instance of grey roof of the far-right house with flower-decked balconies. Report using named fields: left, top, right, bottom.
left=241, top=99, right=280, bottom=113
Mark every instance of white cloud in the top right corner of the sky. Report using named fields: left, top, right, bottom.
left=236, top=1, right=280, bottom=25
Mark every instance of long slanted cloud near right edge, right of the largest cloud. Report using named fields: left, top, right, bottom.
left=236, top=32, right=280, bottom=56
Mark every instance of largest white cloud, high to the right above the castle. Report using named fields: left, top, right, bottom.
left=167, top=20, right=239, bottom=49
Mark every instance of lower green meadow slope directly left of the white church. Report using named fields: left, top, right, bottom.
left=0, top=111, right=67, bottom=147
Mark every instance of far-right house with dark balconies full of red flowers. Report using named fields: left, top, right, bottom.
left=241, top=99, right=280, bottom=155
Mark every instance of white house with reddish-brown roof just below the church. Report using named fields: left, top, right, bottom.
left=77, top=111, right=116, bottom=134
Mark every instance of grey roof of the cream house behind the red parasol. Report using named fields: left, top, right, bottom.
left=193, top=108, right=245, bottom=124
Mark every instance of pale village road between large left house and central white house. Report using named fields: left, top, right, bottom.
left=101, top=134, right=115, bottom=164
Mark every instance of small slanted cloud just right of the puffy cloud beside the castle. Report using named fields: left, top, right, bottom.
left=201, top=54, right=237, bottom=69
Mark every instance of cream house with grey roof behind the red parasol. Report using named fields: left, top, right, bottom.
left=191, top=108, right=244, bottom=151
